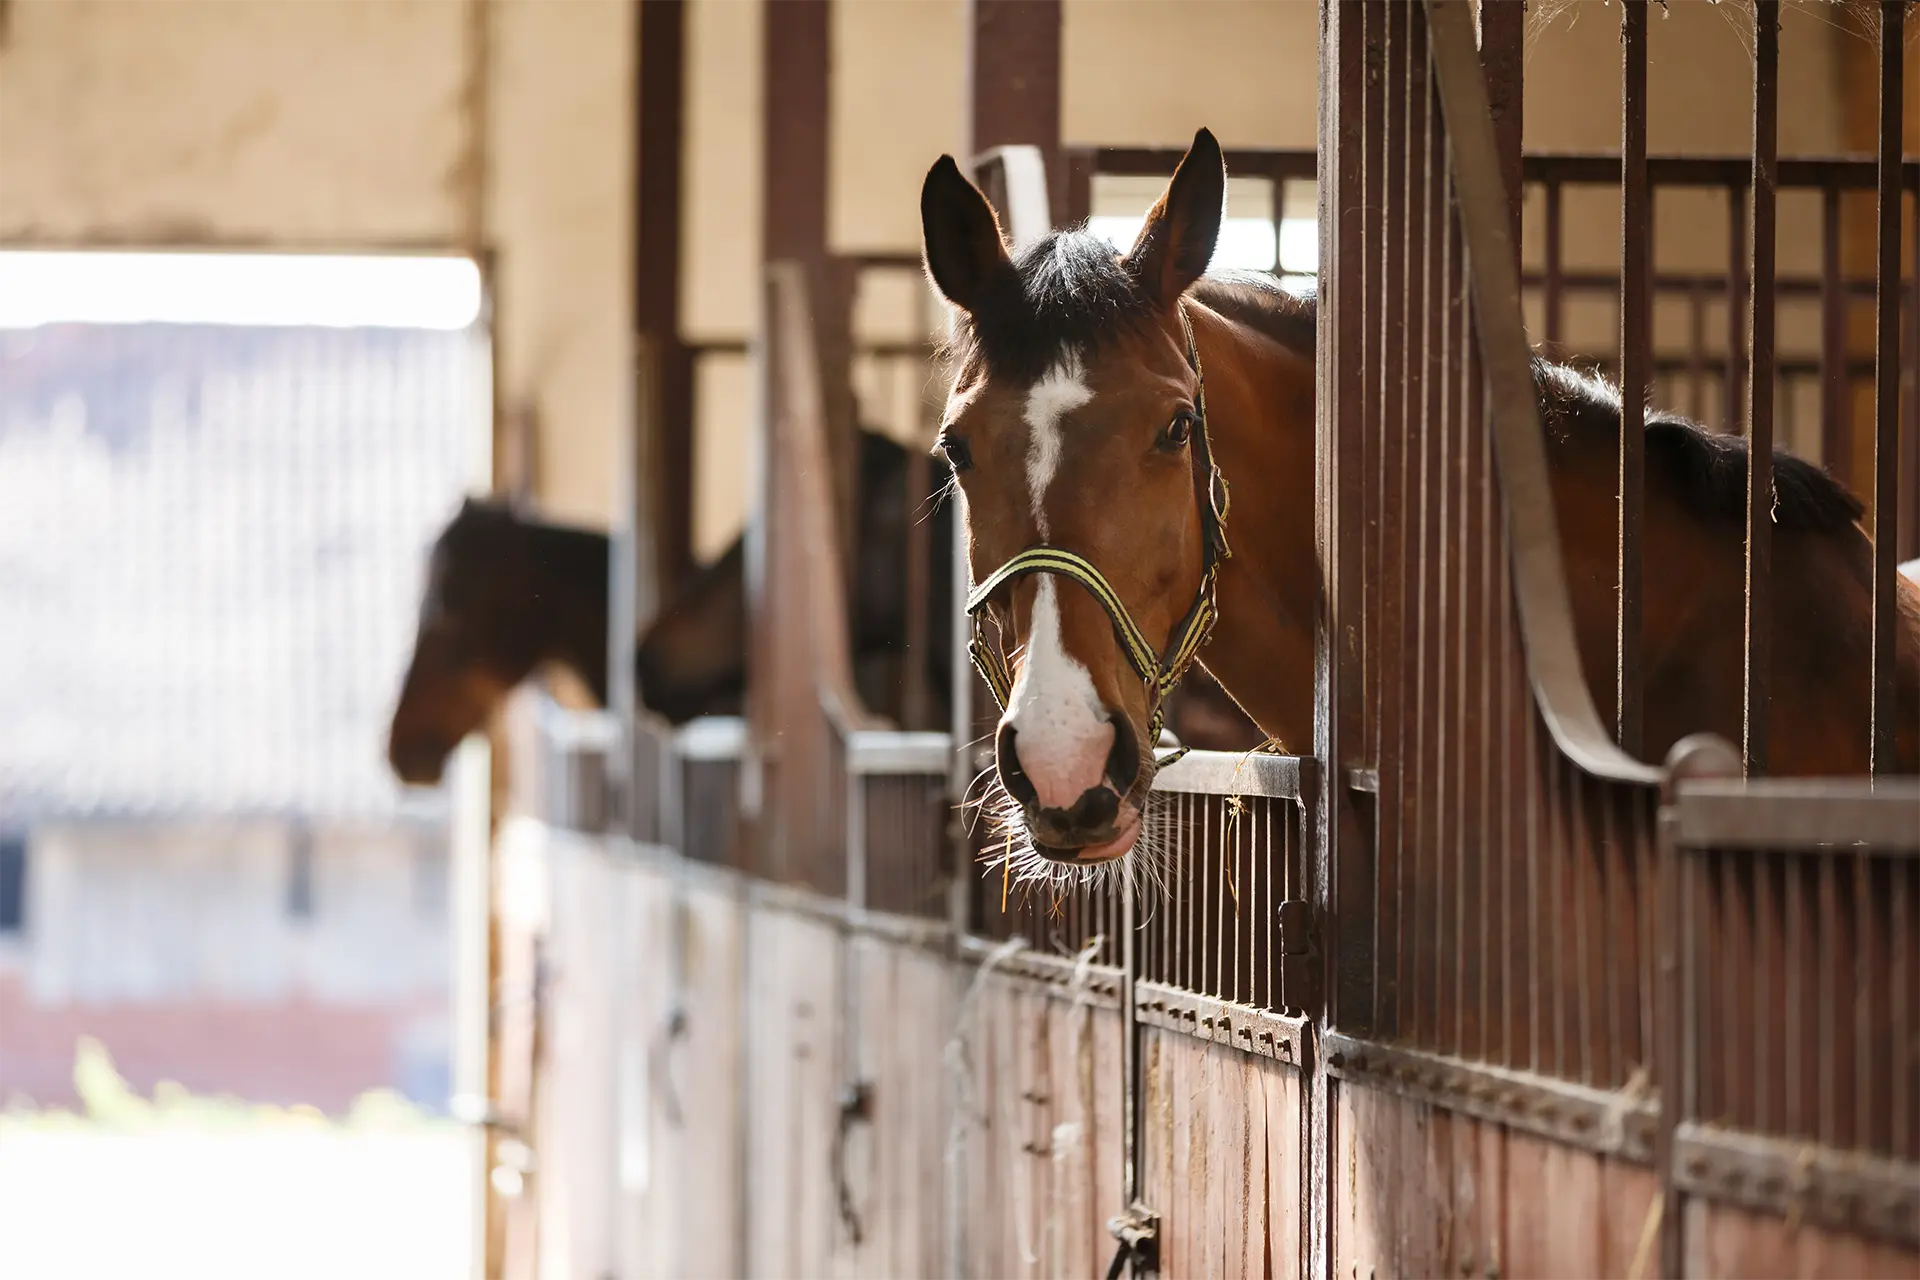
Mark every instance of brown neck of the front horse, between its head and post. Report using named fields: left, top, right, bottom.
left=1190, top=305, right=1319, bottom=750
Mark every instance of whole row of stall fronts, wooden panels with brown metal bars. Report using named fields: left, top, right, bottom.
left=510, top=0, right=1920, bottom=1276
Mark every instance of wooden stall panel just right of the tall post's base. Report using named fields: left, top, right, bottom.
left=1332, top=1082, right=1666, bottom=1280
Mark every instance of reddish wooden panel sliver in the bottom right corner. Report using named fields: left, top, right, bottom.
left=1686, top=1199, right=1920, bottom=1280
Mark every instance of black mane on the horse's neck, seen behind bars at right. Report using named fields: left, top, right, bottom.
left=1532, top=357, right=1866, bottom=533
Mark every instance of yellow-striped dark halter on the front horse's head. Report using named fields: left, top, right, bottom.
left=966, top=305, right=1233, bottom=768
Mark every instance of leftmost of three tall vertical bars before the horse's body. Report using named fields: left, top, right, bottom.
left=1613, top=0, right=1653, bottom=756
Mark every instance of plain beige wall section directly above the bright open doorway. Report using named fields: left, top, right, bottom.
left=0, top=0, right=465, bottom=246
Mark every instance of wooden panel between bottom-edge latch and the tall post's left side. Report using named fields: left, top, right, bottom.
left=1140, top=1029, right=1305, bottom=1278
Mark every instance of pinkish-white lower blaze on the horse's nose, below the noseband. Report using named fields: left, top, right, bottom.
left=1004, top=576, right=1114, bottom=808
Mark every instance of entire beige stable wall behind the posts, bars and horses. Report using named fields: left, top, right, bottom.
left=0, top=0, right=1873, bottom=541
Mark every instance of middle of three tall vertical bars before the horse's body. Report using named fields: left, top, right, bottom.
left=1741, top=0, right=1780, bottom=777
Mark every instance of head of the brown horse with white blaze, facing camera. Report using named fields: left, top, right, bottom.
left=920, top=130, right=1225, bottom=869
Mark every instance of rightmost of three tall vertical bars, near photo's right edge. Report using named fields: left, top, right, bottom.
left=1870, top=0, right=1907, bottom=777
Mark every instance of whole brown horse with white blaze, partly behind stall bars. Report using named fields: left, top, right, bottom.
left=920, top=130, right=1920, bottom=867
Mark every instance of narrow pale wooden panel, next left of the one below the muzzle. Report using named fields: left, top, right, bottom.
left=837, top=938, right=954, bottom=1280
